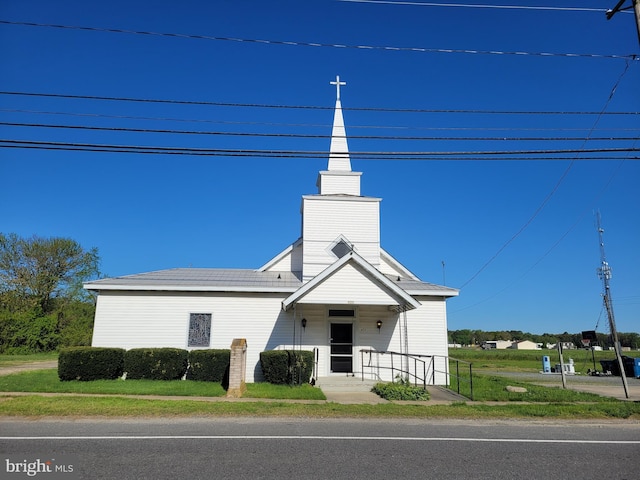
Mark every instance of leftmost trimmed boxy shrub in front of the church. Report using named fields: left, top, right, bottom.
left=58, top=347, right=124, bottom=381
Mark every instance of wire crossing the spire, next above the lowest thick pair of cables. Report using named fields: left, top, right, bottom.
left=0, top=122, right=638, bottom=142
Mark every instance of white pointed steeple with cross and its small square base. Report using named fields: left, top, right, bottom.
left=317, top=76, right=362, bottom=195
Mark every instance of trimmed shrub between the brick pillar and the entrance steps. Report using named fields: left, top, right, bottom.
left=260, top=350, right=313, bottom=385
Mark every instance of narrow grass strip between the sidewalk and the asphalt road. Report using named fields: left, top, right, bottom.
left=0, top=395, right=640, bottom=420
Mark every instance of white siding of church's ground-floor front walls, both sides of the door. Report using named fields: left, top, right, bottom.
left=92, top=286, right=447, bottom=384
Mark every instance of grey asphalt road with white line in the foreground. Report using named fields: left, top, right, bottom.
left=0, top=418, right=640, bottom=480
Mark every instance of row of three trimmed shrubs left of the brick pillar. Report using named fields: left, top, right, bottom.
left=58, top=347, right=230, bottom=383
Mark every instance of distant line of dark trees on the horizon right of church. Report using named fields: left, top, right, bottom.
left=449, top=329, right=640, bottom=350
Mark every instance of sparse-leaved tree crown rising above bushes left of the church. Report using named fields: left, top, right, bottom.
left=0, top=233, right=99, bottom=315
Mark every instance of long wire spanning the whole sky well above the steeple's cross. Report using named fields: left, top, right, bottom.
left=0, top=20, right=637, bottom=60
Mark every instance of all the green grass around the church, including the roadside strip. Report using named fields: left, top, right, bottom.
left=0, top=350, right=640, bottom=420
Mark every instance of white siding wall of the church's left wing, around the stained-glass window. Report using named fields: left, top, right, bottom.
left=92, top=292, right=293, bottom=382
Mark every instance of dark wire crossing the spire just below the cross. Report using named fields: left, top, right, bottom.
left=0, top=90, right=640, bottom=116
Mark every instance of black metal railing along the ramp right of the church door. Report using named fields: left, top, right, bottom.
left=360, top=349, right=473, bottom=400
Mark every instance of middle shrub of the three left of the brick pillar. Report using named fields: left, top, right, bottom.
left=124, top=348, right=189, bottom=380
